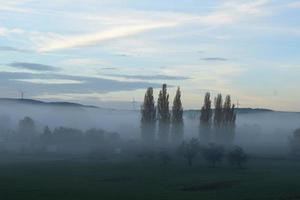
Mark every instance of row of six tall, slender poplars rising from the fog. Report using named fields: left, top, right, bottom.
left=141, top=84, right=236, bottom=143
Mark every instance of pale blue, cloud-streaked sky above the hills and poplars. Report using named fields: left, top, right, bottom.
left=0, top=0, right=300, bottom=111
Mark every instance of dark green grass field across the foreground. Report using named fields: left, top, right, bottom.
left=0, top=156, right=300, bottom=200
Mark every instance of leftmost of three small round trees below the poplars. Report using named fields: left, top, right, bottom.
left=178, top=138, right=200, bottom=166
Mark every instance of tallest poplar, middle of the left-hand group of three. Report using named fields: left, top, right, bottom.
left=157, top=84, right=170, bottom=143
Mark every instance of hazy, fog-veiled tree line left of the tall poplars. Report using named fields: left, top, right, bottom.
left=0, top=116, right=121, bottom=153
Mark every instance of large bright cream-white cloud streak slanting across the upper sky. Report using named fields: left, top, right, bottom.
left=25, top=0, right=269, bottom=52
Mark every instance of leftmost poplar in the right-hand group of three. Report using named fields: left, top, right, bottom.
left=199, top=92, right=212, bottom=142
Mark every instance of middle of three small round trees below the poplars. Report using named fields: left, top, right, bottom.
left=202, top=144, right=224, bottom=167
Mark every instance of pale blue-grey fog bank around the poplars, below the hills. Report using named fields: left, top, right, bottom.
left=0, top=99, right=300, bottom=155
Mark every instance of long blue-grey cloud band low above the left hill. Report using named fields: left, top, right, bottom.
left=0, top=72, right=161, bottom=95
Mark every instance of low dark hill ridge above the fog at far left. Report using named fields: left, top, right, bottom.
left=0, top=98, right=98, bottom=108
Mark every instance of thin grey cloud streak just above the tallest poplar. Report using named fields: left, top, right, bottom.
left=107, top=74, right=189, bottom=80
